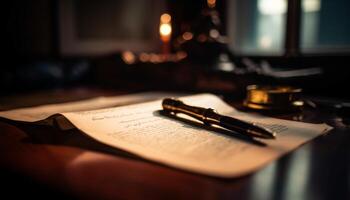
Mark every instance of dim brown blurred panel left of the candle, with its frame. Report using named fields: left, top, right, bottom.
left=57, top=0, right=165, bottom=56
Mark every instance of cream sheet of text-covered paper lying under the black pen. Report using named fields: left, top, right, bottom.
left=0, top=94, right=332, bottom=178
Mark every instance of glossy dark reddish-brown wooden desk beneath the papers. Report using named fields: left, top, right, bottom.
left=0, top=90, right=350, bottom=200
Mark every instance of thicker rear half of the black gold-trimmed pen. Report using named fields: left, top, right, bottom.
left=162, top=98, right=221, bottom=124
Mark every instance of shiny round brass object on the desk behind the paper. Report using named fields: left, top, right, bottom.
left=243, top=85, right=304, bottom=111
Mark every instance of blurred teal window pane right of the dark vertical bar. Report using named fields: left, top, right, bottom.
left=300, top=0, right=350, bottom=53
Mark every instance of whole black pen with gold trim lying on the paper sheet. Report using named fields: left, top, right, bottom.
left=162, top=98, right=275, bottom=139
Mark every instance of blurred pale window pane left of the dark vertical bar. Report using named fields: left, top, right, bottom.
left=228, top=0, right=287, bottom=54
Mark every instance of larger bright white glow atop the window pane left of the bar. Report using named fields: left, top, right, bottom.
left=258, top=0, right=287, bottom=15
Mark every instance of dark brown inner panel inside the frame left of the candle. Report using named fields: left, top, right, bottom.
left=73, top=0, right=154, bottom=40
